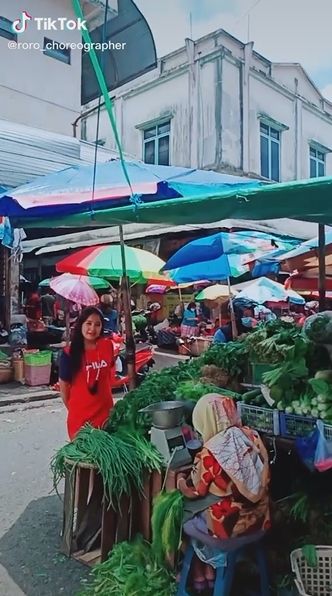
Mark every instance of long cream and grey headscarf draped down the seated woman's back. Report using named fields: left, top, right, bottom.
left=193, top=393, right=269, bottom=503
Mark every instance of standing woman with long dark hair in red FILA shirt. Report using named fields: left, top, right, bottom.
left=59, top=307, right=115, bottom=440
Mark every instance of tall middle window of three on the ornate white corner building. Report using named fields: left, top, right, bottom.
left=260, top=122, right=280, bottom=182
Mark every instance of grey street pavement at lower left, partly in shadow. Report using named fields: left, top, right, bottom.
left=0, top=354, right=182, bottom=596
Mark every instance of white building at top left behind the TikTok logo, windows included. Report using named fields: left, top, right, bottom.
left=0, top=0, right=116, bottom=136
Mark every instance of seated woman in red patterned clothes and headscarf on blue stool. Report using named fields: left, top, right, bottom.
left=178, top=393, right=270, bottom=591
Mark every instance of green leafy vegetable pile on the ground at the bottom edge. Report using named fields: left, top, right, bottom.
left=77, top=538, right=177, bottom=596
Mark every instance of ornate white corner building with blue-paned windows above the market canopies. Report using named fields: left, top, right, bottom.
left=82, top=30, right=332, bottom=181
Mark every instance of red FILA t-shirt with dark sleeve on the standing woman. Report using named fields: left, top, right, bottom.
left=59, top=338, right=115, bottom=440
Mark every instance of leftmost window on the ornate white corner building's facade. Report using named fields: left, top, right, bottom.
left=143, top=120, right=171, bottom=166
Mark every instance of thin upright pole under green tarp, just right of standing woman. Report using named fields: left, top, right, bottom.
left=119, top=226, right=136, bottom=389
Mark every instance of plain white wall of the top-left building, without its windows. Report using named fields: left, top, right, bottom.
left=0, top=0, right=81, bottom=135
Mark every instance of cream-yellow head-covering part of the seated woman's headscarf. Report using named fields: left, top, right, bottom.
left=193, top=393, right=240, bottom=443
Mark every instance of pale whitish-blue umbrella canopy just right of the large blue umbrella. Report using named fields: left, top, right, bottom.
left=235, top=277, right=305, bottom=304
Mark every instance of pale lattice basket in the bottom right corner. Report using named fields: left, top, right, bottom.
left=290, top=546, right=332, bottom=596
